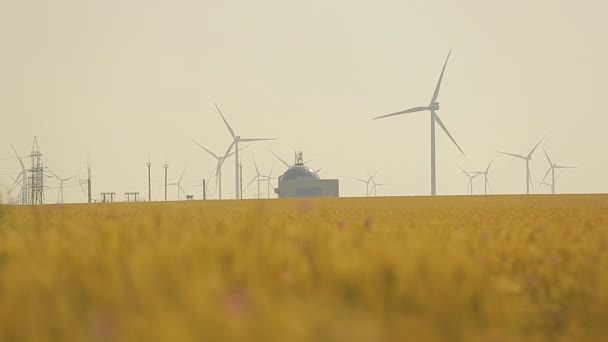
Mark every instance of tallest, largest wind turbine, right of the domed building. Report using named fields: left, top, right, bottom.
left=374, top=50, right=464, bottom=196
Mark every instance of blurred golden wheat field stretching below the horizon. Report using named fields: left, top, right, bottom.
left=0, top=195, right=608, bottom=342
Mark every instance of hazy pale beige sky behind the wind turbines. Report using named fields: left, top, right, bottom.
left=0, top=0, right=608, bottom=202
